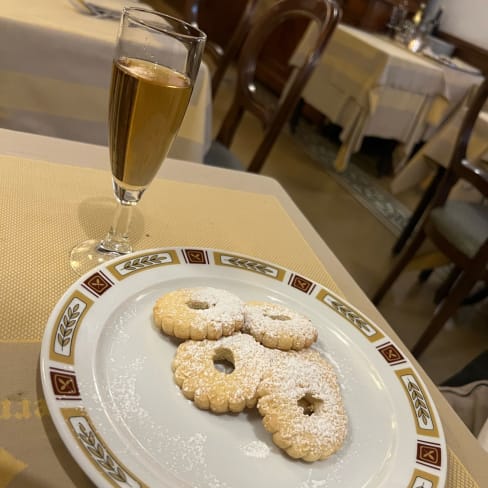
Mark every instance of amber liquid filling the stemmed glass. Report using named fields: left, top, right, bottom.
left=109, top=58, right=191, bottom=189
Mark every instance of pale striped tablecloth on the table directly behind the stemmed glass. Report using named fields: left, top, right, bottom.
left=0, top=0, right=212, bottom=162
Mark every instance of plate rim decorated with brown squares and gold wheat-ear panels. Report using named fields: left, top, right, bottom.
left=40, top=247, right=447, bottom=488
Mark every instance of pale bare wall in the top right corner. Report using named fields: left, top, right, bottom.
left=440, top=0, right=488, bottom=50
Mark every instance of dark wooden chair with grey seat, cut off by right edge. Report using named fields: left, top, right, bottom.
left=373, top=80, right=488, bottom=356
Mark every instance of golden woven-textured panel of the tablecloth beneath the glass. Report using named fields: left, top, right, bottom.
left=0, top=157, right=339, bottom=342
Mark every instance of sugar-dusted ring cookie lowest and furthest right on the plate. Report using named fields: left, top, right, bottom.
left=257, top=349, right=347, bottom=462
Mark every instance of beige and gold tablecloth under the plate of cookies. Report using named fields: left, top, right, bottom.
left=0, top=133, right=488, bottom=488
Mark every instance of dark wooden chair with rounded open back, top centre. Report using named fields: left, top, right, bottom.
left=205, top=0, right=341, bottom=173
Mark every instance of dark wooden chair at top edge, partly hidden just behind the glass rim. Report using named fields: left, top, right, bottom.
left=182, top=0, right=258, bottom=96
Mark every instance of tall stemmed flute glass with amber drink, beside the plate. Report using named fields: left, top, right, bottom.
left=70, top=7, right=206, bottom=274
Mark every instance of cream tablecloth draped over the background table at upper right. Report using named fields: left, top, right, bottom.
left=291, top=24, right=483, bottom=170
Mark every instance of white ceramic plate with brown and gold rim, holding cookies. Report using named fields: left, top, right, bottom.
left=40, top=248, right=447, bottom=488
